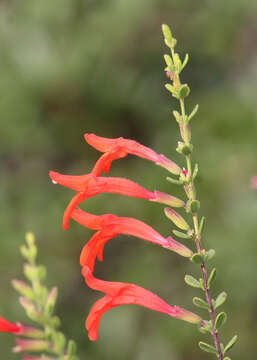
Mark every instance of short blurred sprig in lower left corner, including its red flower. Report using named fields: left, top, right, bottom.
left=0, top=233, right=78, bottom=360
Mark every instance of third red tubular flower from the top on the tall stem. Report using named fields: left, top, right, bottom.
left=71, top=208, right=192, bottom=271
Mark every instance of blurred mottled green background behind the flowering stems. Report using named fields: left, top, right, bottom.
left=0, top=0, right=257, bottom=360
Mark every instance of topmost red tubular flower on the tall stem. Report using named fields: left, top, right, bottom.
left=84, top=134, right=181, bottom=176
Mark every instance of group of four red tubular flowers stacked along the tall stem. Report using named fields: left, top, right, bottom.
left=49, top=134, right=201, bottom=340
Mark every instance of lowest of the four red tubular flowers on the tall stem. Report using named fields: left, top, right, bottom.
left=82, top=266, right=201, bottom=341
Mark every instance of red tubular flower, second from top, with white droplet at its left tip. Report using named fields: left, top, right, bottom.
left=49, top=171, right=184, bottom=229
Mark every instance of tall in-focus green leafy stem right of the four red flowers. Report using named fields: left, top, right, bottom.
left=162, top=25, right=237, bottom=360
